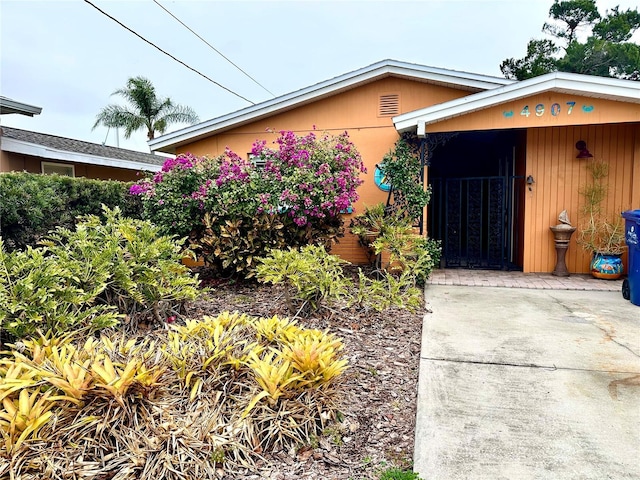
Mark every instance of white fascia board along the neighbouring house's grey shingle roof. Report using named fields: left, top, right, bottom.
left=2, top=137, right=162, bottom=172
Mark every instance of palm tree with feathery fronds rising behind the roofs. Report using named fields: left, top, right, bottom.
left=93, top=77, right=199, bottom=140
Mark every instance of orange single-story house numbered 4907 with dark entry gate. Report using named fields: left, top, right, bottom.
left=149, top=60, right=640, bottom=273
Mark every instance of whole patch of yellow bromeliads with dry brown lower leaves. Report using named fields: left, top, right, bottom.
left=0, top=312, right=347, bottom=480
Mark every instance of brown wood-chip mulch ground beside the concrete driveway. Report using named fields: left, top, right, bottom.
left=187, top=283, right=424, bottom=480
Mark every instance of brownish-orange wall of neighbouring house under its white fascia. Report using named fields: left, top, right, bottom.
left=0, top=151, right=139, bottom=182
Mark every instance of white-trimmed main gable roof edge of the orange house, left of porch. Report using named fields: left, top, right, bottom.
left=148, top=60, right=513, bottom=153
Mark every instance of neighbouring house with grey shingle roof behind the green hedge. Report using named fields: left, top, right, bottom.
left=0, top=126, right=166, bottom=181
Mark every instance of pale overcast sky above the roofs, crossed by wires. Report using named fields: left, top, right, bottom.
left=0, top=0, right=638, bottom=151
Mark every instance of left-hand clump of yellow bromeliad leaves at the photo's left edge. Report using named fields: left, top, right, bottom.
left=0, top=335, right=164, bottom=453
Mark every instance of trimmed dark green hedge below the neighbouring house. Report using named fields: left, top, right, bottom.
left=0, top=172, right=142, bottom=251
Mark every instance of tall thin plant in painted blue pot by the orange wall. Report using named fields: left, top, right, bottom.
left=577, top=160, right=626, bottom=280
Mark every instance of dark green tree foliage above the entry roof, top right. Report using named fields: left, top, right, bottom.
left=500, top=0, right=640, bottom=80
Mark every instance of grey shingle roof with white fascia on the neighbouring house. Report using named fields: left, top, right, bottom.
left=1, top=127, right=165, bottom=172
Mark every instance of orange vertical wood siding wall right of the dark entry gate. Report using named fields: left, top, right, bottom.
left=524, top=123, right=640, bottom=273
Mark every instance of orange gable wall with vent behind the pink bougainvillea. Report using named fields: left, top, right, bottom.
left=177, top=78, right=469, bottom=263
